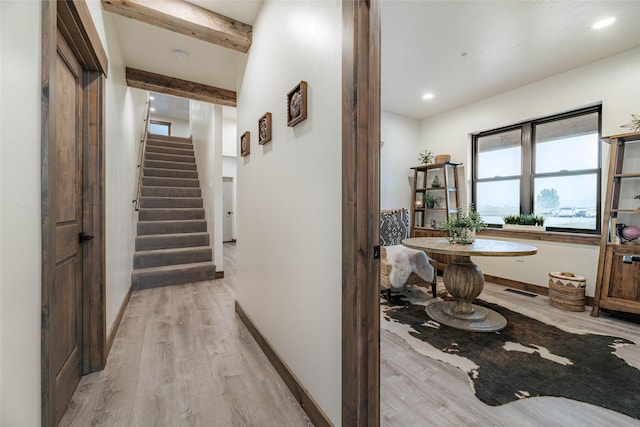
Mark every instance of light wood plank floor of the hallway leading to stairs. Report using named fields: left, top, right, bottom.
left=60, top=243, right=312, bottom=427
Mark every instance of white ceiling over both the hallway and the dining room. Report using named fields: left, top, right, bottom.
left=105, top=0, right=640, bottom=119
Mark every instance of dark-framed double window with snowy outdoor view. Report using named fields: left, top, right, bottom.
left=472, top=106, right=601, bottom=234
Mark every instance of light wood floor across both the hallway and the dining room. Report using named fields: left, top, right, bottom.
left=61, top=244, right=640, bottom=427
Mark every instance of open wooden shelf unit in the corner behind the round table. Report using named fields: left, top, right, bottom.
left=411, top=162, right=462, bottom=269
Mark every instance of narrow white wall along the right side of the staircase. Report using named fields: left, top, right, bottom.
left=189, top=100, right=224, bottom=271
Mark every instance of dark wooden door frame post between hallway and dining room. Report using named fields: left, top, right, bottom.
left=342, top=0, right=380, bottom=427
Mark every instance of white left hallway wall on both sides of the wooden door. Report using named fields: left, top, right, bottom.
left=0, top=0, right=145, bottom=427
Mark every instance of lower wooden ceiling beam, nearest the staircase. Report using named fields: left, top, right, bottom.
left=126, top=67, right=236, bottom=107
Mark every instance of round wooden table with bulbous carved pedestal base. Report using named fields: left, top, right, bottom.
left=402, top=237, right=537, bottom=332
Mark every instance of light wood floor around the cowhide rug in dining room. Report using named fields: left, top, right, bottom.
left=380, top=284, right=640, bottom=427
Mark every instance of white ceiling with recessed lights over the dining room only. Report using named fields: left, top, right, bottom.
left=381, top=0, right=640, bottom=119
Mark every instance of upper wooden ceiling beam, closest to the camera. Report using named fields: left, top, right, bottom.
left=102, top=0, right=253, bottom=53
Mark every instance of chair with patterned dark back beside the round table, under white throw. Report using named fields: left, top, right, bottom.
left=380, top=208, right=438, bottom=302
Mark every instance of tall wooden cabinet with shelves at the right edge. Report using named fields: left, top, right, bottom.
left=591, top=132, right=640, bottom=316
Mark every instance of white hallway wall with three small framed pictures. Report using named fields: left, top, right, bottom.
left=237, top=0, right=342, bottom=425
